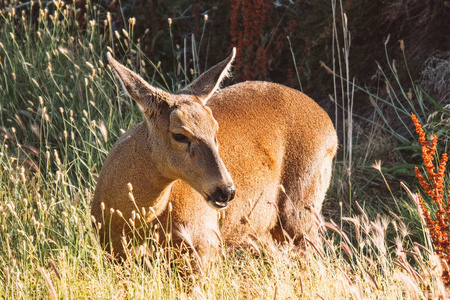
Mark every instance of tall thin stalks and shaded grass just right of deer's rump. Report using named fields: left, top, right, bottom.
left=321, top=0, right=450, bottom=238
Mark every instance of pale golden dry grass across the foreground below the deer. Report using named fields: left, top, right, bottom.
left=0, top=148, right=445, bottom=299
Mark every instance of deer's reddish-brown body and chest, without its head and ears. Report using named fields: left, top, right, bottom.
left=92, top=51, right=337, bottom=257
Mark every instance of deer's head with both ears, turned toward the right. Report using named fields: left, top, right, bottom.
left=108, top=49, right=236, bottom=209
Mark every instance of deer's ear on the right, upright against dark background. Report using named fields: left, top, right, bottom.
left=177, top=48, right=236, bottom=104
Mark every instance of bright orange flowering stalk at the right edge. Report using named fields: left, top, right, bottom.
left=411, top=114, right=450, bottom=286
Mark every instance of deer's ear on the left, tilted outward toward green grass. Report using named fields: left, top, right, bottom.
left=107, top=52, right=171, bottom=116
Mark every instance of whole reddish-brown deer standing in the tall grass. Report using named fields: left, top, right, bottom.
left=91, top=48, right=338, bottom=261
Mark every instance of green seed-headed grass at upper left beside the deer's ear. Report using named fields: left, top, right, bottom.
left=0, top=2, right=151, bottom=188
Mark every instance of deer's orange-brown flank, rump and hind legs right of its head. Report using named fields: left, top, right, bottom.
left=209, top=82, right=337, bottom=245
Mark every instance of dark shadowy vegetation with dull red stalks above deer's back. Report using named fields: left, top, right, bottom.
left=100, top=0, right=450, bottom=102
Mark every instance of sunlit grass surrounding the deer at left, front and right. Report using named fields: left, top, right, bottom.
left=0, top=2, right=449, bottom=299
